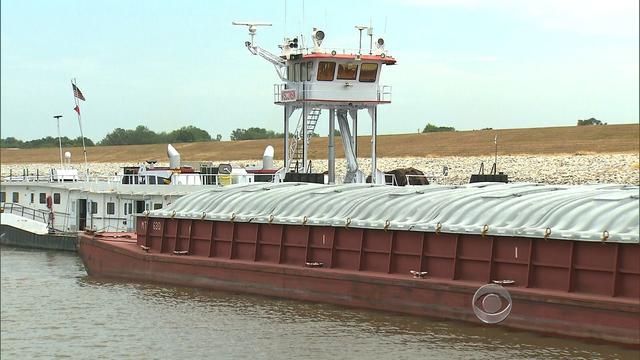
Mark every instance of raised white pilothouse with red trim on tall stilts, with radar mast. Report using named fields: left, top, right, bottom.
left=233, top=22, right=396, bottom=184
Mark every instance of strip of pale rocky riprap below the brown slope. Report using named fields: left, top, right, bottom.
left=1, top=153, right=640, bottom=185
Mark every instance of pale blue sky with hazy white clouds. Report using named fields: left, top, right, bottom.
left=0, top=0, right=640, bottom=140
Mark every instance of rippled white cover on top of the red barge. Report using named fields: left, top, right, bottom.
left=150, top=183, right=640, bottom=243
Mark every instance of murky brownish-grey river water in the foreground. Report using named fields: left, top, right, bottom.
left=0, top=247, right=640, bottom=360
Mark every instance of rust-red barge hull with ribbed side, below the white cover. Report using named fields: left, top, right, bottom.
left=79, top=217, right=640, bottom=347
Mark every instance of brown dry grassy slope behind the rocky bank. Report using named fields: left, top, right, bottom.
left=0, top=124, right=640, bottom=164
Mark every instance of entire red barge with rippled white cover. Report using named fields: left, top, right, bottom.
left=79, top=183, right=640, bottom=346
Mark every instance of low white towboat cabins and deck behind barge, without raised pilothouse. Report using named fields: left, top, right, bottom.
left=0, top=144, right=278, bottom=248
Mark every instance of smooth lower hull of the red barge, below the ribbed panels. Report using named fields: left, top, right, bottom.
left=80, top=229, right=640, bottom=346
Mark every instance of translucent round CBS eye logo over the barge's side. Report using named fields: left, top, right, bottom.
left=471, top=284, right=513, bottom=324
